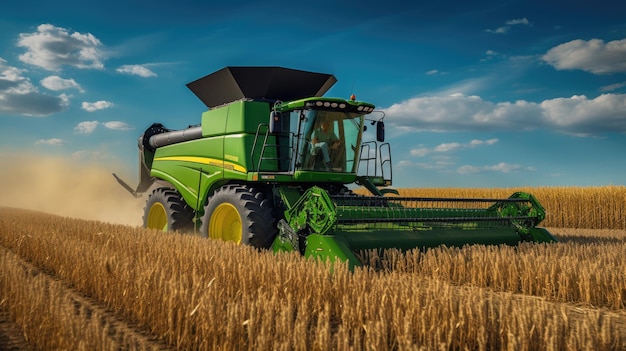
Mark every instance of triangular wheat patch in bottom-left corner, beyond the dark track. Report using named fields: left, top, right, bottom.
left=0, top=247, right=168, bottom=350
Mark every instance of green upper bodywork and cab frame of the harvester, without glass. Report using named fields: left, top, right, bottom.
left=148, top=98, right=366, bottom=211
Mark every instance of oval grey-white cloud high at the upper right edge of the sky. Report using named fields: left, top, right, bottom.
left=542, top=39, right=626, bottom=74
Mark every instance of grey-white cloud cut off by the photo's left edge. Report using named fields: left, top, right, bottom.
left=0, top=57, right=69, bottom=117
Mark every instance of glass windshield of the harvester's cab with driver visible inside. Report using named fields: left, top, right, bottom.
left=291, top=110, right=364, bottom=173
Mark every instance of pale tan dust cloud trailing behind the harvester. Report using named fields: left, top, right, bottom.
left=0, top=154, right=145, bottom=226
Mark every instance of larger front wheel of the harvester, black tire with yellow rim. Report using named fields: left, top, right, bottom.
left=200, top=185, right=276, bottom=248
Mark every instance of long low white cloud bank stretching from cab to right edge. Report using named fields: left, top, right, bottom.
left=383, top=94, right=626, bottom=135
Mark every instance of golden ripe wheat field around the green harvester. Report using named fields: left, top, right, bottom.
left=0, top=187, right=626, bottom=350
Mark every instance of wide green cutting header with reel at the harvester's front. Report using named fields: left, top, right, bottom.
left=273, top=187, right=556, bottom=268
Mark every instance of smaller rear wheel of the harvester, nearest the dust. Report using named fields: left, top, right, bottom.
left=143, top=188, right=194, bottom=232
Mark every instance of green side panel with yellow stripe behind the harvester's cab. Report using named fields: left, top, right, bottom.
left=150, top=101, right=290, bottom=210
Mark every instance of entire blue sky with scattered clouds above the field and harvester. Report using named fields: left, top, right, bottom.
left=0, top=0, right=626, bottom=187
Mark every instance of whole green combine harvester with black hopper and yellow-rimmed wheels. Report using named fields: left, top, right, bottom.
left=114, top=67, right=556, bottom=267
